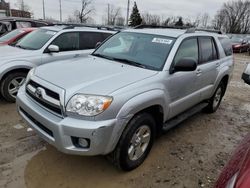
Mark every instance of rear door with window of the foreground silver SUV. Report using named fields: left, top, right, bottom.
left=197, top=36, right=220, bottom=100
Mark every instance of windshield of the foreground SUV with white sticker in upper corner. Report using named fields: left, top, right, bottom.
left=93, top=32, right=175, bottom=70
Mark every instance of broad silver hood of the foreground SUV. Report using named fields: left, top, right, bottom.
left=35, top=56, right=158, bottom=98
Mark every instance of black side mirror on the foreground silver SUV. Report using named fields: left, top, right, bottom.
left=171, top=58, right=198, bottom=73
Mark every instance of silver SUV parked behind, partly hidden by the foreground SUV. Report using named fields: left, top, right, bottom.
left=0, top=26, right=115, bottom=102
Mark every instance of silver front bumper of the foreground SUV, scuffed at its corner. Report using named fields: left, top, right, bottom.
left=17, top=88, right=124, bottom=156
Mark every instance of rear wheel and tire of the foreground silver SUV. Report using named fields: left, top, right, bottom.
left=204, top=82, right=226, bottom=113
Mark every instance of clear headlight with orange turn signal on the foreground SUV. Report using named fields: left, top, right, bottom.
left=66, top=94, right=113, bottom=116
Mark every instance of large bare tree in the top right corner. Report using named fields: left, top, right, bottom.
left=213, top=0, right=250, bottom=33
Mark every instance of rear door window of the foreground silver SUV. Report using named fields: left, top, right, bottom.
left=199, top=37, right=218, bottom=64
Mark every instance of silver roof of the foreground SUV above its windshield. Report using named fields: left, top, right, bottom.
left=125, top=28, right=186, bottom=38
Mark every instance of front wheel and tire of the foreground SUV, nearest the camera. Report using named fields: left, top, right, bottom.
left=107, top=113, right=156, bottom=171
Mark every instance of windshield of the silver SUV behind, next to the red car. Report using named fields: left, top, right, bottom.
left=16, top=29, right=56, bottom=50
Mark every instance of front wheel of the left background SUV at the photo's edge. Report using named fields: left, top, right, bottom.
left=1, top=72, right=27, bottom=103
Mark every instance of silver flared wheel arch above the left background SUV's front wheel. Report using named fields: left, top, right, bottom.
left=0, top=61, right=35, bottom=80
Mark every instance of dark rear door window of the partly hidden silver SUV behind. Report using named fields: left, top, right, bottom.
left=80, top=32, right=108, bottom=50
